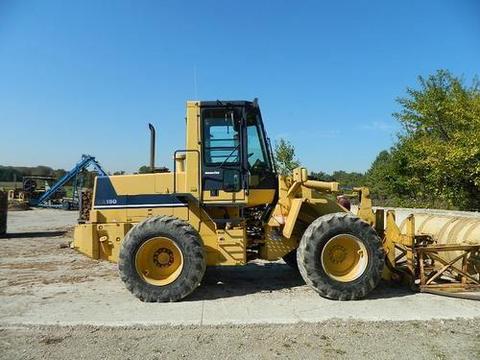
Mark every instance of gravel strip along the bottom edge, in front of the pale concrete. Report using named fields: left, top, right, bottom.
left=0, top=320, right=480, bottom=360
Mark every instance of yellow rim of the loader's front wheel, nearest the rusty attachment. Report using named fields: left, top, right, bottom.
left=321, top=234, right=368, bottom=282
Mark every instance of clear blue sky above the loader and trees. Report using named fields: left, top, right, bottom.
left=0, top=0, right=480, bottom=172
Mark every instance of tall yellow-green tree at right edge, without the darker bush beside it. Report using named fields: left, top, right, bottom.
left=394, top=70, right=480, bottom=209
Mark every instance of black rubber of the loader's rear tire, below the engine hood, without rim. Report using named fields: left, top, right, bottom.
left=118, top=216, right=205, bottom=302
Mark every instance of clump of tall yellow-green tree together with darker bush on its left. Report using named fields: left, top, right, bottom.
left=368, top=70, right=480, bottom=209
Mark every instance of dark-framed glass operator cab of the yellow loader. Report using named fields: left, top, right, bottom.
left=199, top=100, right=277, bottom=206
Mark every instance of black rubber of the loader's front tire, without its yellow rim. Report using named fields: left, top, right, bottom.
left=297, top=213, right=385, bottom=300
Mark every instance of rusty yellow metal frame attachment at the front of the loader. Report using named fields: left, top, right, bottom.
left=384, top=211, right=480, bottom=300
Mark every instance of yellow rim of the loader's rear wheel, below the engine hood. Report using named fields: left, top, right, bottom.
left=135, top=237, right=183, bottom=286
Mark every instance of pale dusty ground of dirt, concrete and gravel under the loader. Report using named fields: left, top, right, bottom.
left=0, top=209, right=480, bottom=359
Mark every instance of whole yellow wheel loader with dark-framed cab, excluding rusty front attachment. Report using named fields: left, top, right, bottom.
left=73, top=100, right=480, bottom=302
